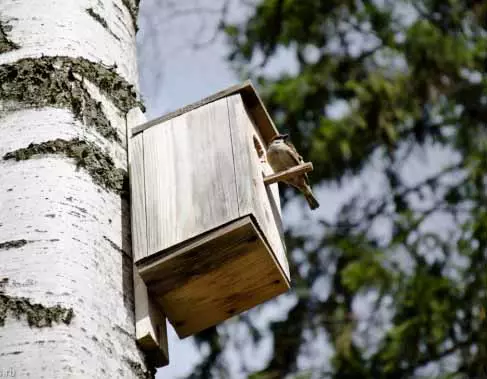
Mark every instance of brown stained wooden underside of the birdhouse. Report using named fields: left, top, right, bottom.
left=138, top=216, right=289, bottom=338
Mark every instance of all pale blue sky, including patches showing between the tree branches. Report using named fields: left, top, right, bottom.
left=137, top=0, right=460, bottom=379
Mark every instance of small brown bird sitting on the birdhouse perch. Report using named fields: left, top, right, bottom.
left=266, top=134, right=320, bottom=210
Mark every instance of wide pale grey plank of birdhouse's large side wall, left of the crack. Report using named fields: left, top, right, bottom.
left=143, top=99, right=239, bottom=254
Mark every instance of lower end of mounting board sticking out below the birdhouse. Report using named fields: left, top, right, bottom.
left=134, top=267, right=169, bottom=367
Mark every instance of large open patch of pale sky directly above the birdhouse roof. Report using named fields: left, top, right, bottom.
left=137, top=0, right=239, bottom=119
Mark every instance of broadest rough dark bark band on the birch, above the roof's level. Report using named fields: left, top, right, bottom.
left=0, top=57, right=143, bottom=142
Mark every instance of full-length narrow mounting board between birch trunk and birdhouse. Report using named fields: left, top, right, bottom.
left=127, top=108, right=169, bottom=367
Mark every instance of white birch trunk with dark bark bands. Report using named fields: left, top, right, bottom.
left=0, top=0, right=153, bottom=378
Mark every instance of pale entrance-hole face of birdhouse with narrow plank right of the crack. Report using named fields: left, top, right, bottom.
left=227, top=95, right=290, bottom=279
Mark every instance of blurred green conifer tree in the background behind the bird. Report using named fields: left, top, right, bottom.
left=185, top=0, right=487, bottom=379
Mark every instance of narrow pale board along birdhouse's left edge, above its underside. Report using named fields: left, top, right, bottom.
left=127, top=108, right=147, bottom=261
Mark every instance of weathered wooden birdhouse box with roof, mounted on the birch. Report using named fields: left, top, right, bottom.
left=130, top=82, right=290, bottom=338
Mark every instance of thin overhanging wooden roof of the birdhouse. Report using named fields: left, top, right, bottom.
left=132, top=80, right=279, bottom=144
